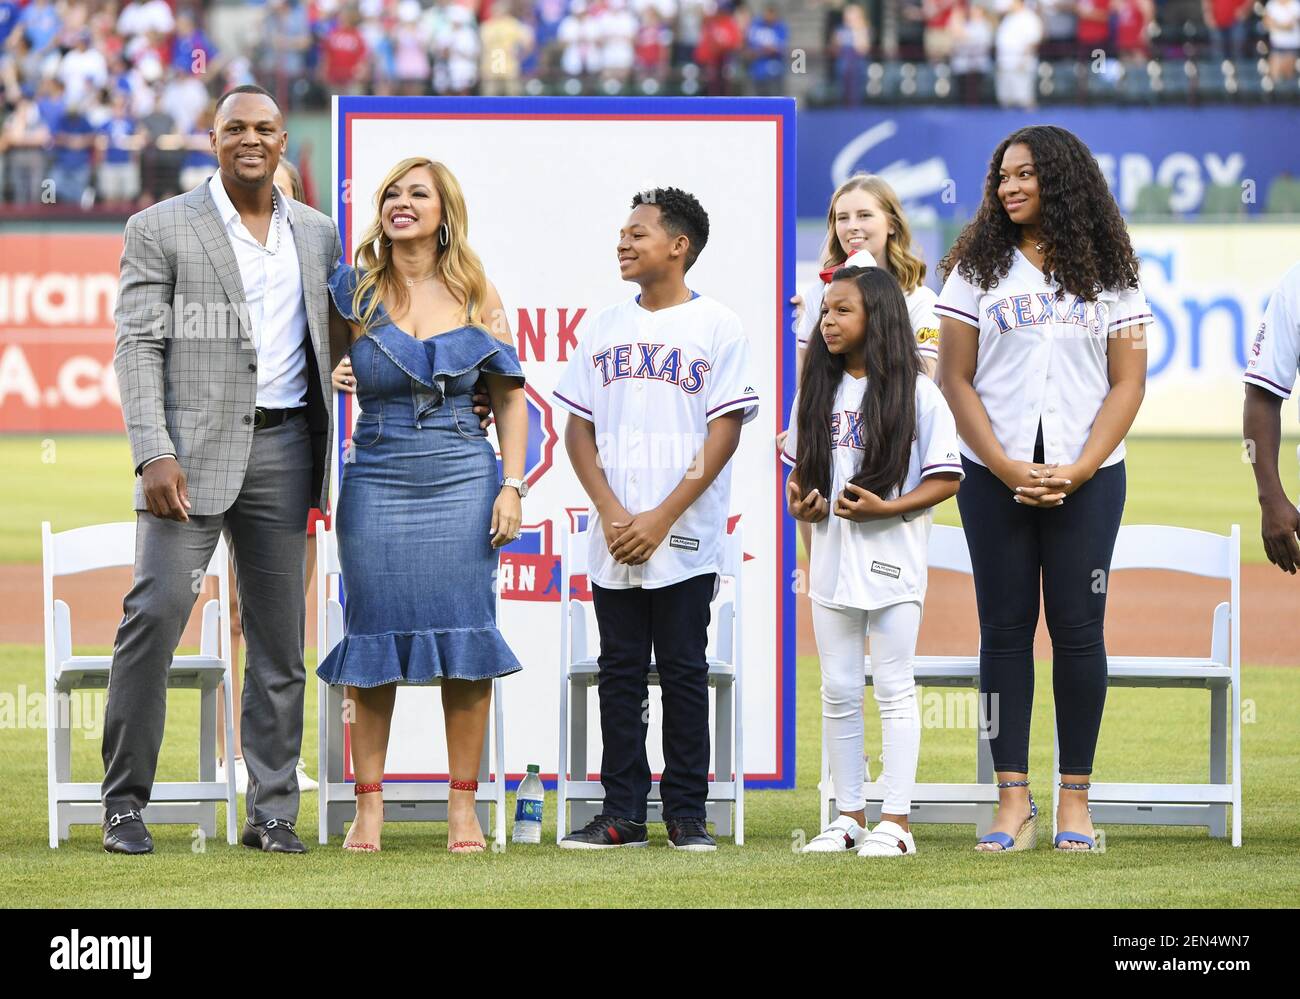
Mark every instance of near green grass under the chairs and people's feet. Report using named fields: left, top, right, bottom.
left=0, top=645, right=1300, bottom=908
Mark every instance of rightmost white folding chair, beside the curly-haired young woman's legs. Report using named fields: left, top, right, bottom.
left=1052, top=524, right=1242, bottom=847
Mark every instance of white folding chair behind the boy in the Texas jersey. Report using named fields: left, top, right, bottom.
left=555, top=527, right=745, bottom=847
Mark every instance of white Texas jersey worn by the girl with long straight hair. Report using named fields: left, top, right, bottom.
left=781, top=373, right=965, bottom=610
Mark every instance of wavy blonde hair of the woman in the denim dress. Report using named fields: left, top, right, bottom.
left=352, top=156, right=488, bottom=329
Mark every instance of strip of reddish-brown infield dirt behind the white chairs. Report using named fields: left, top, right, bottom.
left=0, top=565, right=1300, bottom=666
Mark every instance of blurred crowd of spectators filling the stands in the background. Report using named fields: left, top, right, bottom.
left=0, top=0, right=1300, bottom=207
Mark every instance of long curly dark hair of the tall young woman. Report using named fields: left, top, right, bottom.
left=939, top=125, right=1138, bottom=302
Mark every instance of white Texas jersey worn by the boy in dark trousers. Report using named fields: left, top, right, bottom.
left=554, top=294, right=758, bottom=589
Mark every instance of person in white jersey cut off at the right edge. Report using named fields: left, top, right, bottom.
left=1242, top=264, right=1300, bottom=575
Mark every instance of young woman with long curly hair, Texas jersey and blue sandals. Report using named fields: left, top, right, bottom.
left=935, top=126, right=1152, bottom=852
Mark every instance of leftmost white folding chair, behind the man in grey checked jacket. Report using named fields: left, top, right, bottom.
left=40, top=520, right=238, bottom=848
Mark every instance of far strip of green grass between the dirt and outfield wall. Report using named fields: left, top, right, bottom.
left=0, top=436, right=1296, bottom=563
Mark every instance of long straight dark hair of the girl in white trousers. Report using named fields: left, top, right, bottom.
left=794, top=267, right=920, bottom=502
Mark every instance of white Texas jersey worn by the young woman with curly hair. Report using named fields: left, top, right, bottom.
left=935, top=250, right=1152, bottom=467
